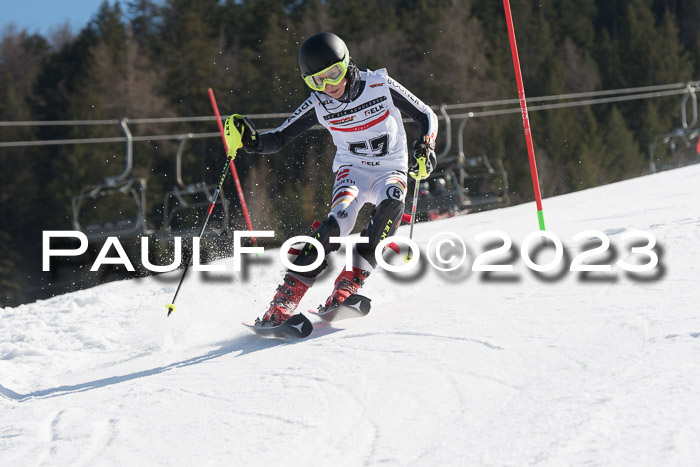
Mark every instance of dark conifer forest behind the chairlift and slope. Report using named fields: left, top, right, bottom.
left=0, top=0, right=700, bottom=306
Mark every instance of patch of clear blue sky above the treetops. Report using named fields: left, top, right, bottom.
left=0, top=0, right=121, bottom=35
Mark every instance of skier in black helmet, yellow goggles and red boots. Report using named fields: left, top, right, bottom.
left=227, top=32, right=438, bottom=326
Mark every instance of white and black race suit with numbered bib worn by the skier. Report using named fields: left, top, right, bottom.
left=260, top=69, right=438, bottom=236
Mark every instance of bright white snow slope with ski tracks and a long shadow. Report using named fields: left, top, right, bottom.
left=0, top=166, right=700, bottom=466
